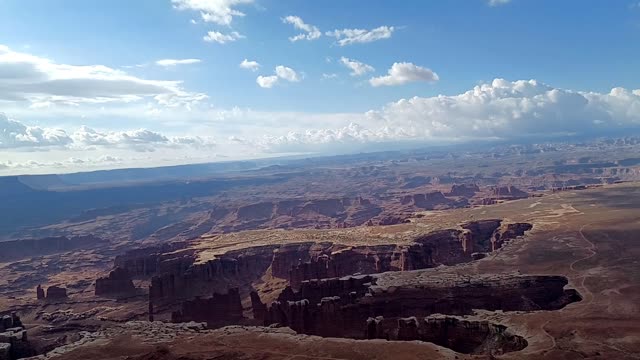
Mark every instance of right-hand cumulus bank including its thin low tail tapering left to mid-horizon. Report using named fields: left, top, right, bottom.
left=246, top=79, right=640, bottom=152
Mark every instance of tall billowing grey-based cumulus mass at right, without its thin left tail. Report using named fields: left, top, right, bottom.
left=369, top=79, right=640, bottom=139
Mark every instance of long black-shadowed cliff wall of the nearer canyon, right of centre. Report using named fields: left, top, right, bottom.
left=264, top=273, right=581, bottom=339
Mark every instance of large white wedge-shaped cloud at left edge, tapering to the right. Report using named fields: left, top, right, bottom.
left=0, top=45, right=206, bottom=108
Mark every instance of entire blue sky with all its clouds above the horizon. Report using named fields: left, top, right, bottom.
left=0, top=0, right=640, bottom=175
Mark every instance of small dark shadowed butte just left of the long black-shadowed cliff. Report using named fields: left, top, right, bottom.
left=171, top=288, right=242, bottom=327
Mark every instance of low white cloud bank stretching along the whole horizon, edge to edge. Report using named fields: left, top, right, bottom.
left=0, top=78, right=640, bottom=173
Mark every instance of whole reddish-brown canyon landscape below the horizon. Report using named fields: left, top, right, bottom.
left=0, top=142, right=640, bottom=360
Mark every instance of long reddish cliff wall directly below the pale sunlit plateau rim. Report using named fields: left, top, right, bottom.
left=149, top=219, right=527, bottom=303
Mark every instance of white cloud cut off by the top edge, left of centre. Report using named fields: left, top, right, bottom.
left=171, top=0, right=253, bottom=26
